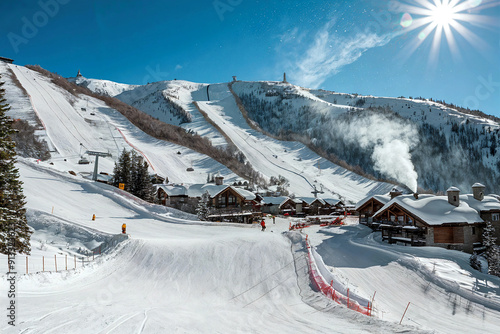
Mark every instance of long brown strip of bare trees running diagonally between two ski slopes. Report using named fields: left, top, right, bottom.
left=26, top=65, right=266, bottom=185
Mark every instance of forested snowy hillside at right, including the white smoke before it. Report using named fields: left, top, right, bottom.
left=233, top=82, right=500, bottom=192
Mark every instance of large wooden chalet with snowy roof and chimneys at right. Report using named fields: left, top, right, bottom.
left=373, top=186, right=500, bottom=253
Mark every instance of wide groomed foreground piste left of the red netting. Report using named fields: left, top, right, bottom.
left=0, top=161, right=414, bottom=333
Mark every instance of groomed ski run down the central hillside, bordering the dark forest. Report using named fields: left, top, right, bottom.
left=198, top=84, right=393, bottom=202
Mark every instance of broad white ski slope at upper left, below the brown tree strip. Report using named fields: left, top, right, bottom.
left=7, top=65, right=238, bottom=183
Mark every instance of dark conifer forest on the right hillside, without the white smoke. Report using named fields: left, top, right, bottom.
left=239, top=91, right=500, bottom=192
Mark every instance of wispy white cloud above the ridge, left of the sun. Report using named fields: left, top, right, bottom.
left=281, top=20, right=391, bottom=88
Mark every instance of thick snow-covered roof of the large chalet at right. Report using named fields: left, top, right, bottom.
left=374, top=195, right=483, bottom=225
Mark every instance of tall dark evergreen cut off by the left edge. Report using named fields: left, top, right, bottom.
left=0, top=78, right=32, bottom=255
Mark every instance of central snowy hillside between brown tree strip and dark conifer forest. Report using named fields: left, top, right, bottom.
left=72, top=75, right=393, bottom=202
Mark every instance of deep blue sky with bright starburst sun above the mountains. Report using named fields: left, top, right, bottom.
left=0, top=0, right=500, bottom=117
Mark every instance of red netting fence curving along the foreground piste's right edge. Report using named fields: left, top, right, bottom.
left=306, top=236, right=372, bottom=316
